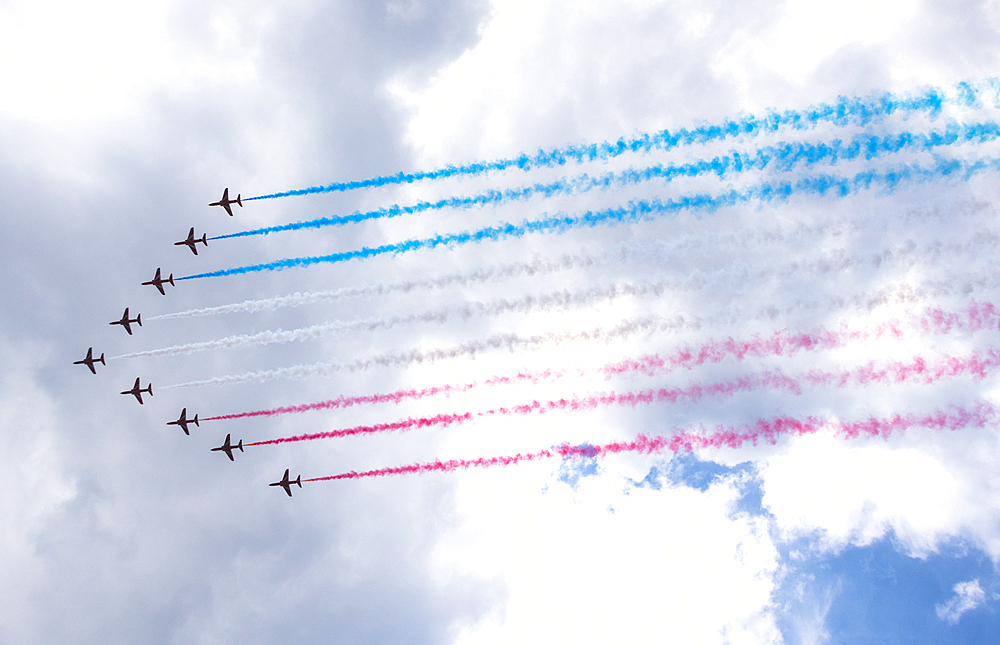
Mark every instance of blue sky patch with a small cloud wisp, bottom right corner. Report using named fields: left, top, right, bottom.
left=776, top=537, right=1000, bottom=645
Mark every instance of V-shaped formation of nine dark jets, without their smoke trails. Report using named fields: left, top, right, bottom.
left=73, top=188, right=302, bottom=497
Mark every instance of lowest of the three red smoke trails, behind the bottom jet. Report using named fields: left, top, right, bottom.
left=303, top=403, right=996, bottom=482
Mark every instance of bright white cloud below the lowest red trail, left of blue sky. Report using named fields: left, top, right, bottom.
left=436, top=457, right=781, bottom=644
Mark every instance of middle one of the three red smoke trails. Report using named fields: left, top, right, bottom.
left=246, top=349, right=1000, bottom=446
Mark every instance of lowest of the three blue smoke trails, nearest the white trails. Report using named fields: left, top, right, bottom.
left=180, top=158, right=1000, bottom=280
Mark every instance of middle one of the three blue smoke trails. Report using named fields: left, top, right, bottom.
left=215, top=121, right=1000, bottom=240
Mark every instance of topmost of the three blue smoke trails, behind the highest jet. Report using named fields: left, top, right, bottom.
left=244, top=78, right=1000, bottom=201
